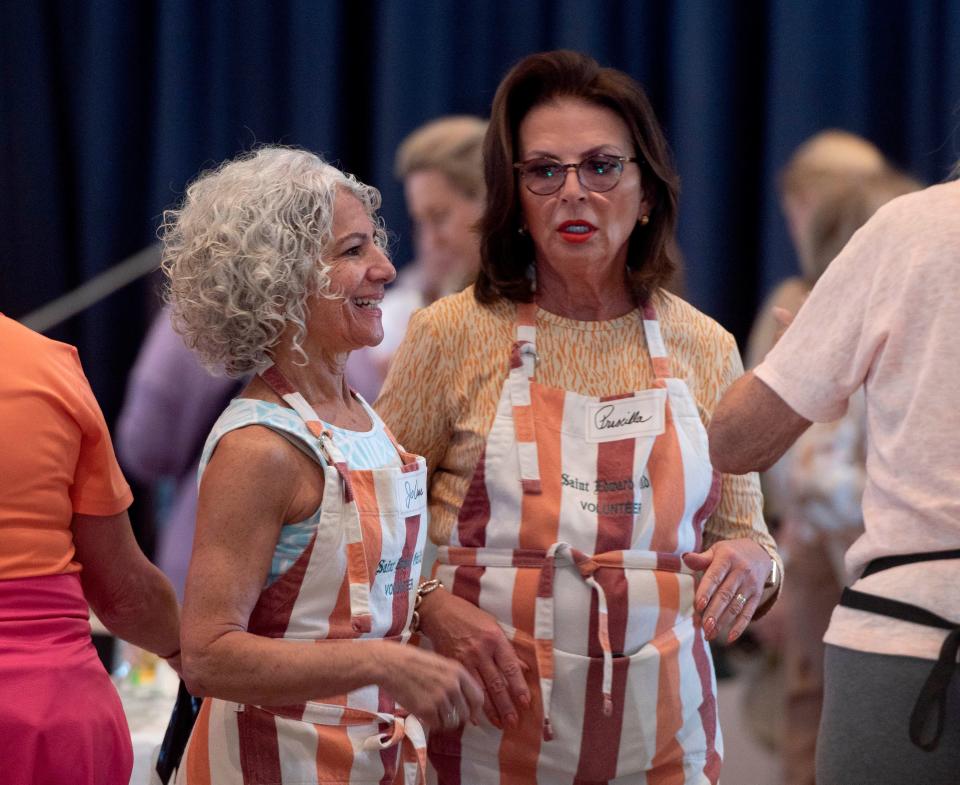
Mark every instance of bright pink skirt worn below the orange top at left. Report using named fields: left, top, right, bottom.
left=0, top=574, right=133, bottom=785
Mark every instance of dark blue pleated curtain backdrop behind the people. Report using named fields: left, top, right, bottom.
left=0, top=0, right=960, bottom=417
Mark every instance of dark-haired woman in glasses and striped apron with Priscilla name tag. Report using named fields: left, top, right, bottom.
left=378, top=51, right=780, bottom=784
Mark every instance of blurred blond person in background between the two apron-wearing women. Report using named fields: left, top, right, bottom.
left=347, top=115, right=487, bottom=401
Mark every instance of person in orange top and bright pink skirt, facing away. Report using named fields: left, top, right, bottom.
left=0, top=314, right=180, bottom=785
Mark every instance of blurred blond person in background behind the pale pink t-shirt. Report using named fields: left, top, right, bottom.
left=749, top=150, right=920, bottom=785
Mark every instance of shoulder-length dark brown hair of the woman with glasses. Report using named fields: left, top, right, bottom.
left=474, top=50, right=680, bottom=303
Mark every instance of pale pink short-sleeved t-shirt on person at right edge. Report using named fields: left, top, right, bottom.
left=755, top=182, right=960, bottom=659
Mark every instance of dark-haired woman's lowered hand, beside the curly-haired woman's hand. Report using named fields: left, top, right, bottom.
left=420, top=589, right=530, bottom=728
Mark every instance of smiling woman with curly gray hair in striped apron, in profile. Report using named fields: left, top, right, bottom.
left=162, top=148, right=482, bottom=783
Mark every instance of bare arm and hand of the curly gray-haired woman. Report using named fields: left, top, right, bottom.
left=183, top=428, right=482, bottom=726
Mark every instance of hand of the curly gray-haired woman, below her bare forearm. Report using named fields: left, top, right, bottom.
left=382, top=644, right=483, bottom=730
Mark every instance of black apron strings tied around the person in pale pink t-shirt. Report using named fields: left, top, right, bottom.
left=840, top=549, right=960, bottom=752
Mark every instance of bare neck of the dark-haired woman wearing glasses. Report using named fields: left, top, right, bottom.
left=536, top=264, right=637, bottom=322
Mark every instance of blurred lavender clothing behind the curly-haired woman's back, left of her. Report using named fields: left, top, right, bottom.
left=115, top=309, right=241, bottom=600
